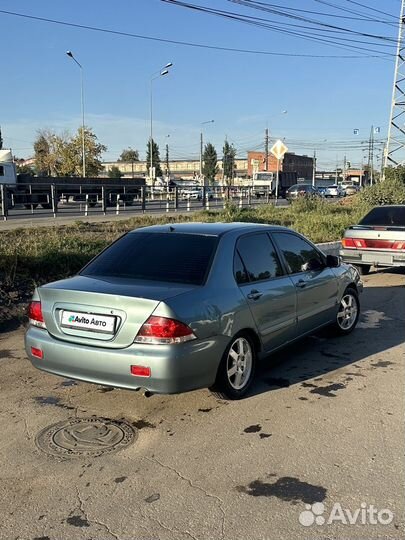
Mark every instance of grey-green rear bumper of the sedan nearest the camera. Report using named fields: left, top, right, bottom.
left=25, top=327, right=228, bottom=394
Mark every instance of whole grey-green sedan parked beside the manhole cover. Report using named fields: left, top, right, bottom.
left=25, top=223, right=362, bottom=399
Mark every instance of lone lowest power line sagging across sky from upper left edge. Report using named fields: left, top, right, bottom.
left=0, top=9, right=388, bottom=59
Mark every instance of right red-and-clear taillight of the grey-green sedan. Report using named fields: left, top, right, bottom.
left=135, top=315, right=196, bottom=344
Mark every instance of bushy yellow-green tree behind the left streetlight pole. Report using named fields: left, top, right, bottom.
left=34, top=127, right=107, bottom=177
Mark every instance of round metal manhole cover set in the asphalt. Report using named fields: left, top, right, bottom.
left=36, top=417, right=136, bottom=457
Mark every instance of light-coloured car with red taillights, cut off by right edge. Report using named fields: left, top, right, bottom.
left=340, top=205, right=405, bottom=274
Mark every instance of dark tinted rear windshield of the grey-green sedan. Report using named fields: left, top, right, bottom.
left=80, top=232, right=218, bottom=285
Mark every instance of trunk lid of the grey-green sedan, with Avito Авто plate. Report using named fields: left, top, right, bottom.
left=38, top=276, right=194, bottom=348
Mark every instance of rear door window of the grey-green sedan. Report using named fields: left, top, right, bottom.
left=236, top=233, right=283, bottom=281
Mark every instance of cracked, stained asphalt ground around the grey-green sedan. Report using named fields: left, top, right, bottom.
left=0, top=271, right=405, bottom=540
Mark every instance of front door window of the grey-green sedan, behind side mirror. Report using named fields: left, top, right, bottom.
left=272, top=232, right=325, bottom=274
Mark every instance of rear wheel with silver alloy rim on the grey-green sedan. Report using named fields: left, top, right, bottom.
left=211, top=332, right=257, bottom=399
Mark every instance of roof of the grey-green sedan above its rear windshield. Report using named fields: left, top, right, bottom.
left=131, top=222, right=290, bottom=236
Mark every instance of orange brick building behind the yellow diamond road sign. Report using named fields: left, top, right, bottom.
left=247, top=151, right=314, bottom=181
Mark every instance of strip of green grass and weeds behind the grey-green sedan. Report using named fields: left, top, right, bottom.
left=0, top=200, right=364, bottom=290
